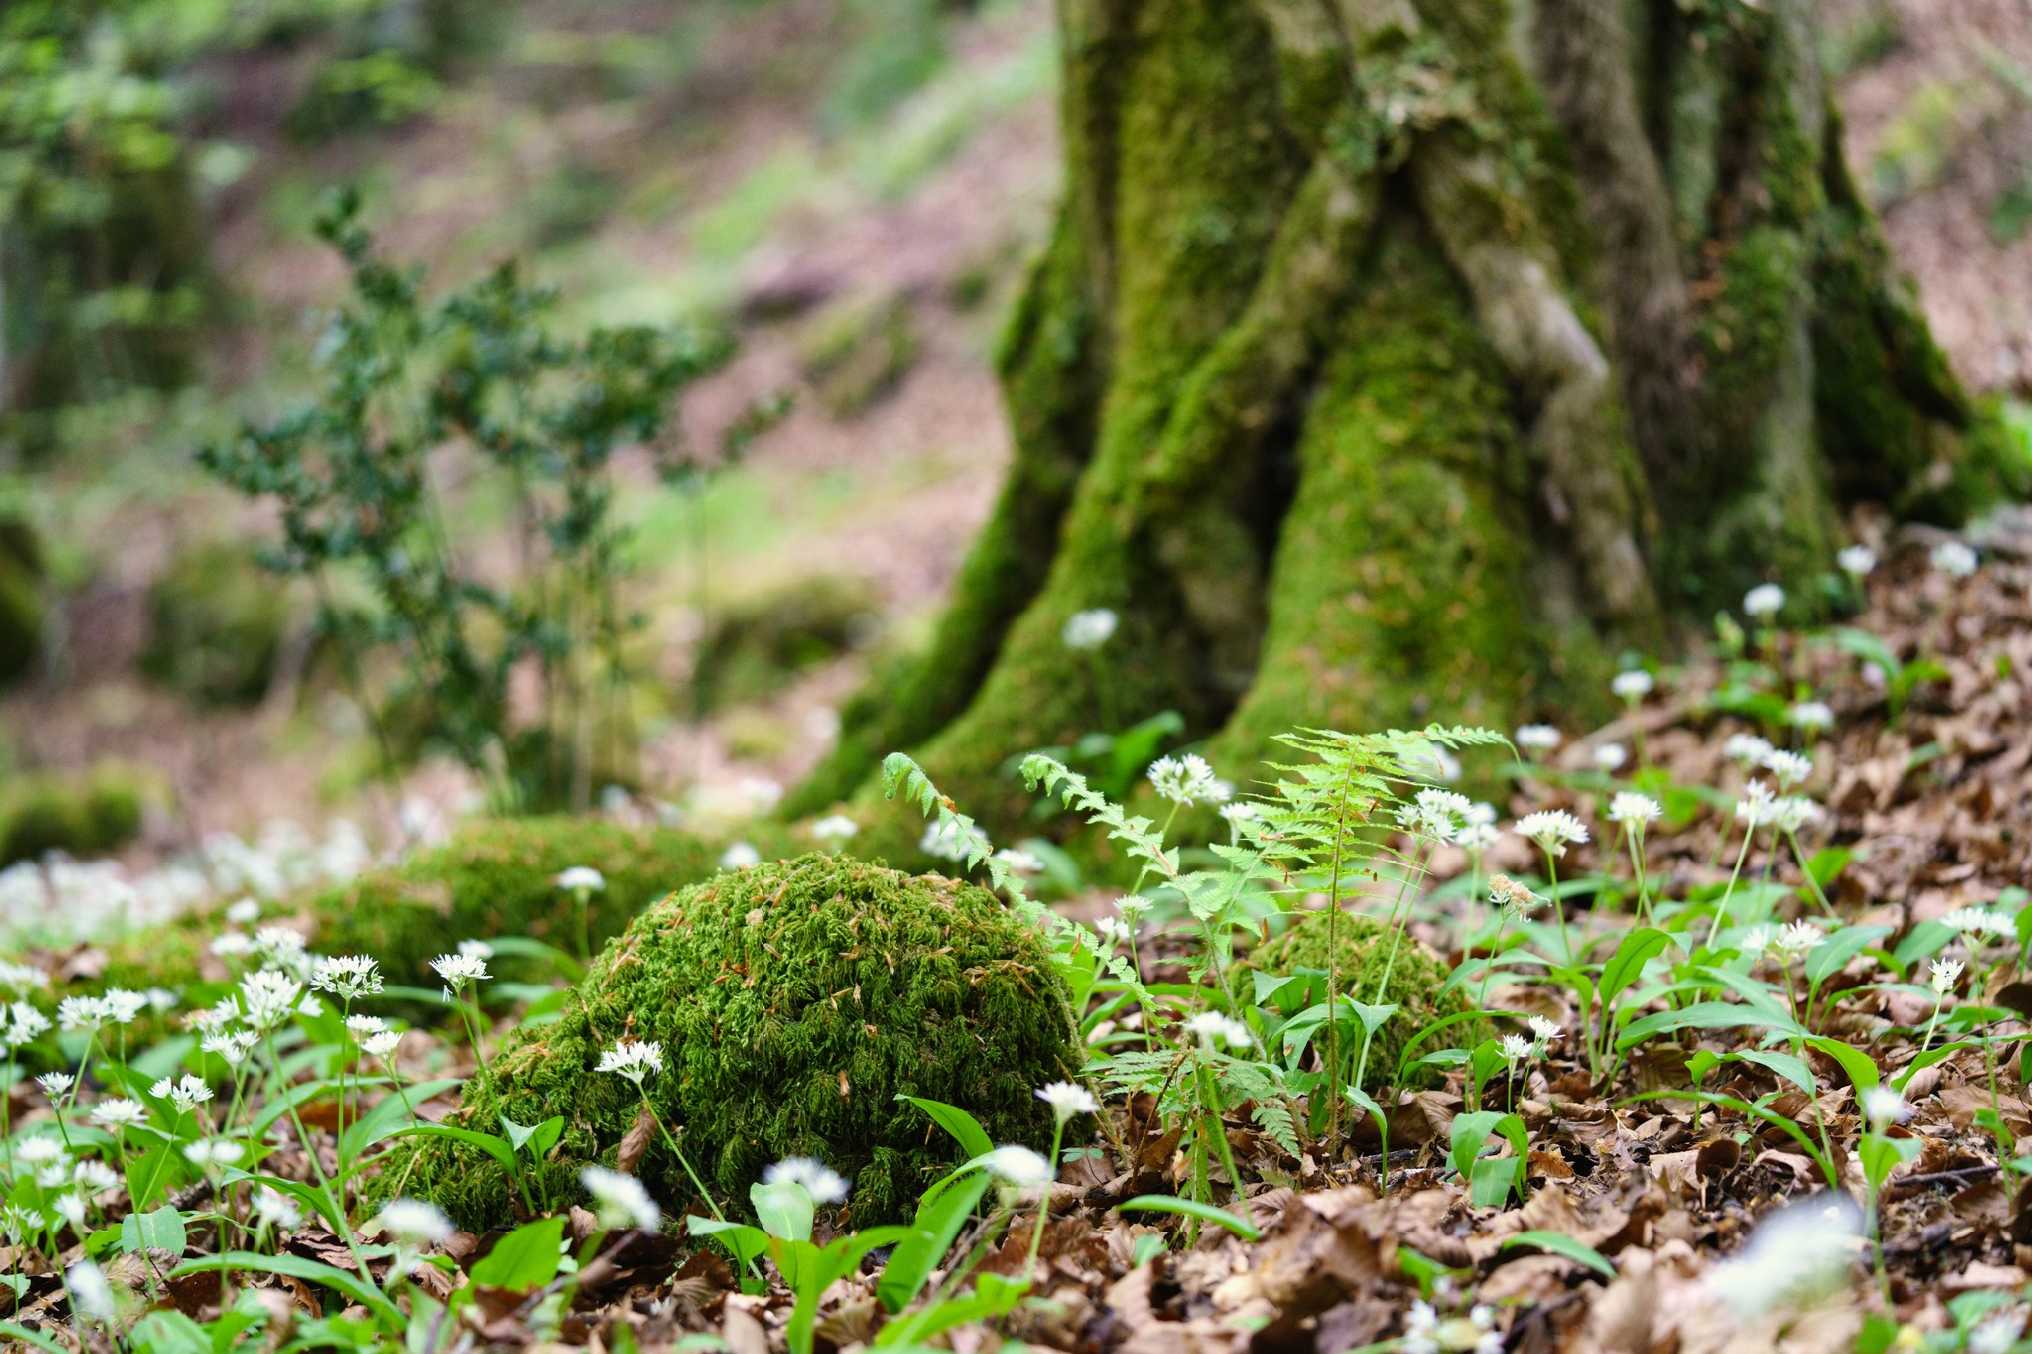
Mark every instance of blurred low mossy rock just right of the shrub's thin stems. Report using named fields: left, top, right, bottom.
left=693, top=577, right=880, bottom=712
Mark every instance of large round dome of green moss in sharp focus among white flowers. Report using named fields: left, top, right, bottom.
left=382, top=856, right=1079, bottom=1228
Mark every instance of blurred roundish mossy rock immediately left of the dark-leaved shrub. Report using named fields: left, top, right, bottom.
left=140, top=543, right=289, bottom=705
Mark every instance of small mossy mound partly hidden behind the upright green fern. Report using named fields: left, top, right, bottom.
left=1237, top=913, right=1467, bottom=1092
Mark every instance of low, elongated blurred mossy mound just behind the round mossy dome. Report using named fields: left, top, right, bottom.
left=106, top=817, right=786, bottom=986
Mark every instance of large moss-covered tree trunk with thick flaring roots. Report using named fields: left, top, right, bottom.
left=790, top=0, right=1973, bottom=821
